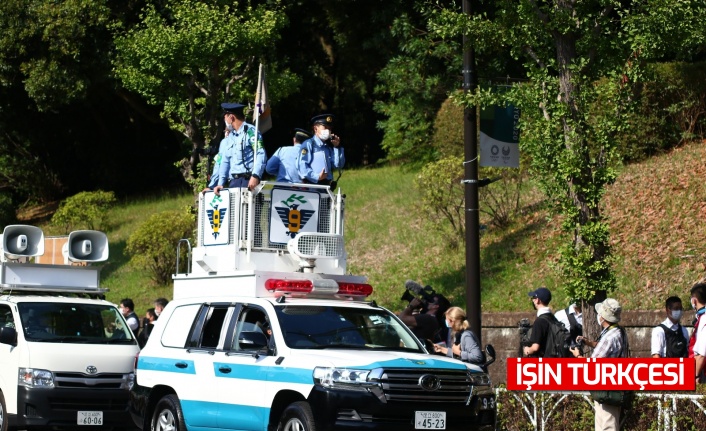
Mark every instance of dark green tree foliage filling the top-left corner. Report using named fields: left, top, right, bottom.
left=0, top=0, right=111, bottom=110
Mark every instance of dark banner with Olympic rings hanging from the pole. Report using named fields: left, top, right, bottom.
left=480, top=91, right=520, bottom=168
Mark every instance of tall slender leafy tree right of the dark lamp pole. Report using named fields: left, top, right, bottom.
left=429, top=0, right=704, bottom=339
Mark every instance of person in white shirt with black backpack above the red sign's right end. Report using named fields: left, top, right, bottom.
left=650, top=296, right=689, bottom=358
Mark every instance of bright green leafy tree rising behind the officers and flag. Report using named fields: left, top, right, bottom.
left=114, top=0, right=299, bottom=189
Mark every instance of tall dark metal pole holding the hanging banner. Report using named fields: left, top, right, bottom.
left=463, top=0, right=483, bottom=345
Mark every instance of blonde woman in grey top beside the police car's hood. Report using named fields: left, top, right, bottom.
left=434, top=307, right=485, bottom=364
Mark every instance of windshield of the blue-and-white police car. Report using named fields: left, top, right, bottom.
left=275, top=305, right=423, bottom=353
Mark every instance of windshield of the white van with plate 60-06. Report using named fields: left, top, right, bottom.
left=17, top=302, right=135, bottom=344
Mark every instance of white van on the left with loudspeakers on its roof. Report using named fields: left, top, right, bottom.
left=0, top=226, right=139, bottom=431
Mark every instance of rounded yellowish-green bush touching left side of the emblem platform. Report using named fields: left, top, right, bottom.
left=126, top=211, right=195, bottom=285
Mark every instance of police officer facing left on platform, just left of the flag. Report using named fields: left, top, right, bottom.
left=213, top=103, right=266, bottom=194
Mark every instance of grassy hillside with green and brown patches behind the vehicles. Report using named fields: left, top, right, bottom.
left=22, top=142, right=706, bottom=314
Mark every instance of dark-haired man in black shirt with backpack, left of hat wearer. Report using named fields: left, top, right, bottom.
left=523, top=287, right=569, bottom=358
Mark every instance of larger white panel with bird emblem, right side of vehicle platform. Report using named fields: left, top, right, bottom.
left=270, top=187, right=319, bottom=244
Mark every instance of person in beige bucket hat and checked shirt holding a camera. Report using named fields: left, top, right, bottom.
left=571, top=298, right=629, bottom=430
